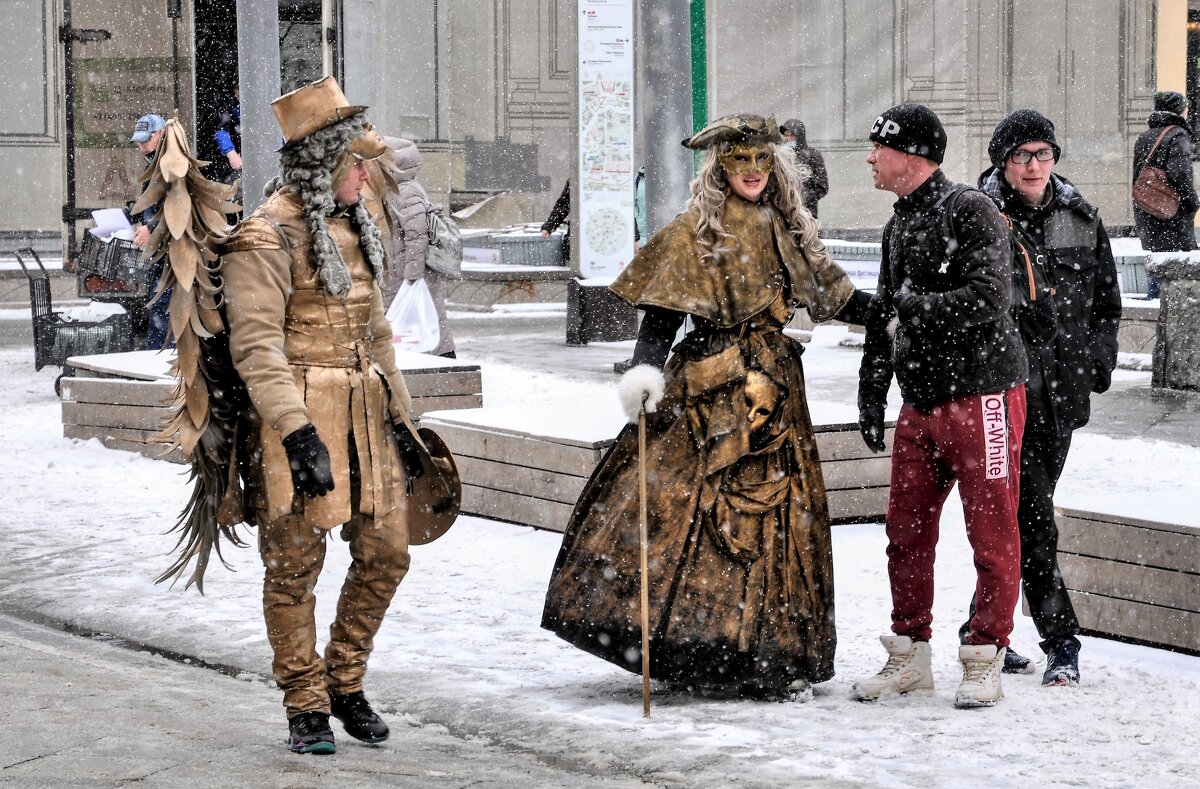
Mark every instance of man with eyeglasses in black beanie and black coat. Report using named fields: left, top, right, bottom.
left=964, top=109, right=1121, bottom=685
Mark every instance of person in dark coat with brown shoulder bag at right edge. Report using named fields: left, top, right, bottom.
left=1132, top=90, right=1200, bottom=299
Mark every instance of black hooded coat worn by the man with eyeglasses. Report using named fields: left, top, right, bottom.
left=979, top=168, right=1121, bottom=432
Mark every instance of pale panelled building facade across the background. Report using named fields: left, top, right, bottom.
left=0, top=0, right=1200, bottom=246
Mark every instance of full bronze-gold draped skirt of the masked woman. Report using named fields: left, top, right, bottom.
left=542, top=326, right=836, bottom=692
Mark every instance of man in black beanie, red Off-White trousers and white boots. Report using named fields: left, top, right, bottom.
left=852, top=104, right=1027, bottom=707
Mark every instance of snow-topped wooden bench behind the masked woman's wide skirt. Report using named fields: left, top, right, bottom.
left=421, top=404, right=893, bottom=531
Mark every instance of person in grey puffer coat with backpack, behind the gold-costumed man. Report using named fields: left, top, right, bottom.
left=383, top=137, right=455, bottom=359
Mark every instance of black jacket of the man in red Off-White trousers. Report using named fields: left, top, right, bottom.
left=858, top=170, right=1028, bottom=411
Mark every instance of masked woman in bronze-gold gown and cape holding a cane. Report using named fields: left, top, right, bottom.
left=542, top=115, right=869, bottom=700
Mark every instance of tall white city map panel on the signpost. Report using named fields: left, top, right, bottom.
left=576, top=0, right=637, bottom=278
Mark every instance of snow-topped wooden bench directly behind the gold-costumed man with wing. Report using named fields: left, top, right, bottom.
left=62, top=350, right=484, bottom=463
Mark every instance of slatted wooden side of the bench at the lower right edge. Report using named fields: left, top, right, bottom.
left=1056, top=507, right=1200, bottom=654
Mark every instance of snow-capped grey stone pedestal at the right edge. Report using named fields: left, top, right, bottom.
left=1146, top=252, right=1200, bottom=392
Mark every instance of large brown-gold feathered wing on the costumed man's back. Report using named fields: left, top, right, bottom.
left=133, top=119, right=243, bottom=594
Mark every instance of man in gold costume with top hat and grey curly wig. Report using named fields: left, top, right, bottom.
left=222, top=78, right=409, bottom=753
